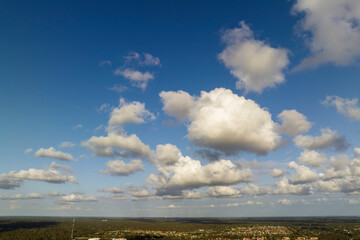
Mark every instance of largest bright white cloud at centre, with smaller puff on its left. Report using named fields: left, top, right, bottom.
left=160, top=88, right=282, bottom=155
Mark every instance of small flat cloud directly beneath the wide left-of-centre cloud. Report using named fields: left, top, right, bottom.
left=100, top=160, right=145, bottom=176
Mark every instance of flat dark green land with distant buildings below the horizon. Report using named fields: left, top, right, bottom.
left=0, top=217, right=360, bottom=240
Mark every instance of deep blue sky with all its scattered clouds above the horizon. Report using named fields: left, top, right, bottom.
left=0, top=0, right=360, bottom=217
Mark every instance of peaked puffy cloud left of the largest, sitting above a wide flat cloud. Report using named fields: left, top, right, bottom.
left=109, top=98, right=155, bottom=128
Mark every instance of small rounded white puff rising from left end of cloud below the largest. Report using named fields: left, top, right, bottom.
left=156, top=144, right=181, bottom=165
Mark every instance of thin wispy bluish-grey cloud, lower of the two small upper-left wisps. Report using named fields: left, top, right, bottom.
left=114, top=68, right=154, bottom=90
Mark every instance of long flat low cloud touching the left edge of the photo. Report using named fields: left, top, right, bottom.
left=0, top=163, right=77, bottom=189
